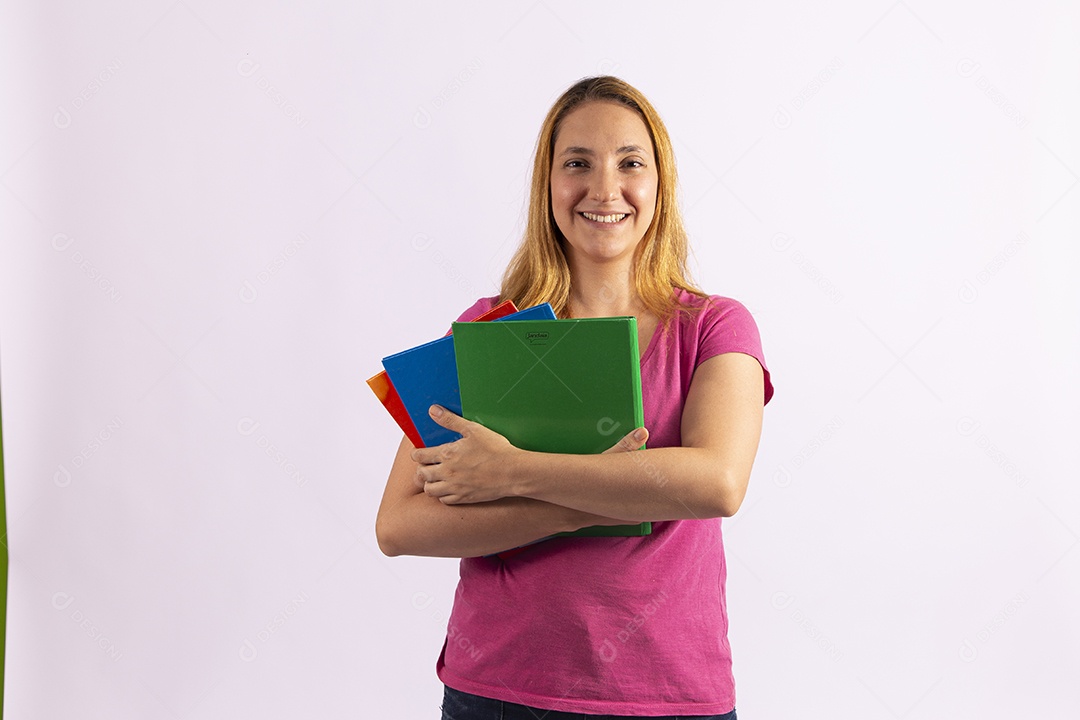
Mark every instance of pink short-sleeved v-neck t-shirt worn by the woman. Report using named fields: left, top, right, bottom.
left=436, top=291, right=772, bottom=715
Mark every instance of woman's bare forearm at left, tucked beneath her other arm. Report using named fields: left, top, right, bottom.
left=375, top=438, right=629, bottom=557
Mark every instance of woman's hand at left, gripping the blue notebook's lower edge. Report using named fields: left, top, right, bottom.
left=411, top=405, right=524, bottom=505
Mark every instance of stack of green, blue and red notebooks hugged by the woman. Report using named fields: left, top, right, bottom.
left=367, top=301, right=652, bottom=544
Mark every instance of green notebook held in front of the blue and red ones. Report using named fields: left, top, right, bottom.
left=454, top=317, right=652, bottom=536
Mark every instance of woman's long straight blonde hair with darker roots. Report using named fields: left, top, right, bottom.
left=500, top=76, right=707, bottom=325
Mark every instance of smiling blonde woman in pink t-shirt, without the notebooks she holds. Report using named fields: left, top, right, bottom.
left=376, top=77, right=772, bottom=720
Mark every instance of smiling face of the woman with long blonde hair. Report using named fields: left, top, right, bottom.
left=551, top=101, right=659, bottom=268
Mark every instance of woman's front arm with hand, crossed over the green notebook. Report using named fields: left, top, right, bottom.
left=413, top=353, right=765, bottom=522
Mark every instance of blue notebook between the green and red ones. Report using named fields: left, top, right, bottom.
left=382, top=302, right=555, bottom=447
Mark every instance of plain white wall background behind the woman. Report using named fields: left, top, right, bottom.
left=0, top=0, right=1080, bottom=720
